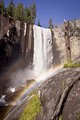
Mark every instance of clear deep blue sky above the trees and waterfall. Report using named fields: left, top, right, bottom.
left=5, top=0, right=80, bottom=27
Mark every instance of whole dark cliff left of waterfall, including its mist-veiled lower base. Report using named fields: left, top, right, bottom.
left=0, top=16, right=34, bottom=96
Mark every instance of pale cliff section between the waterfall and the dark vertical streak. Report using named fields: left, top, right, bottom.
left=53, top=26, right=67, bottom=66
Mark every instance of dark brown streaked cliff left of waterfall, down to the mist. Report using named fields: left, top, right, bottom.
left=0, top=15, right=34, bottom=70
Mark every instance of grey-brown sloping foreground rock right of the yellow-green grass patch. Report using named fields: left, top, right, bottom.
left=36, top=68, right=80, bottom=120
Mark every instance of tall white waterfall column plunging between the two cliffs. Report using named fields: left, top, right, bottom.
left=33, top=25, right=53, bottom=73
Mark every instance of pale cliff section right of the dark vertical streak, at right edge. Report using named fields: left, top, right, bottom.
left=70, top=19, right=80, bottom=60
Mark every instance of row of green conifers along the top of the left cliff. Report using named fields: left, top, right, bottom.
left=0, top=0, right=36, bottom=24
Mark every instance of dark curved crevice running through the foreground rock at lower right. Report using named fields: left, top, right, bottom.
left=52, top=75, right=80, bottom=120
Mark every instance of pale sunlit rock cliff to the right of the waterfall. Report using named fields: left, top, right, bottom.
left=53, top=19, right=80, bottom=65
